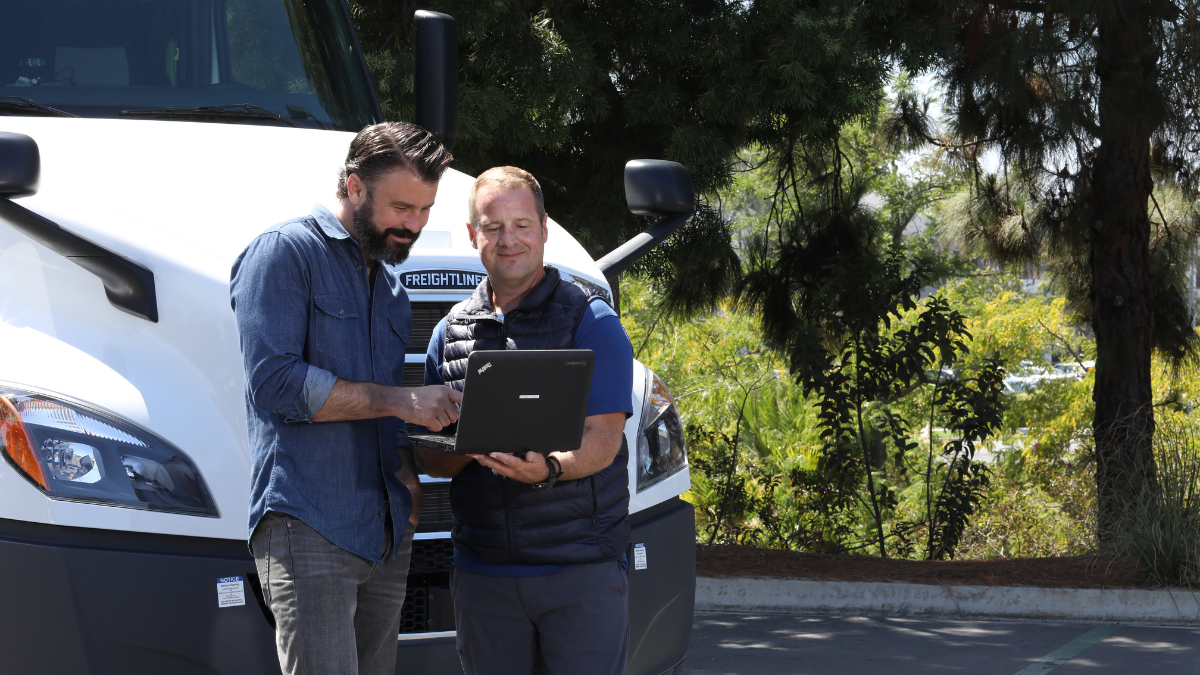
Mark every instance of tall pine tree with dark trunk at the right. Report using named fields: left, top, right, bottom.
left=893, top=0, right=1200, bottom=532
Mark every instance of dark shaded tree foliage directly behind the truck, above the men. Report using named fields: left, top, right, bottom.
left=352, top=0, right=937, bottom=312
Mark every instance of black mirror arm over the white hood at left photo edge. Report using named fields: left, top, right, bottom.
left=0, top=197, right=158, bottom=323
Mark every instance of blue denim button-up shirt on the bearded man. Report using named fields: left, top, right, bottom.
left=229, top=205, right=413, bottom=562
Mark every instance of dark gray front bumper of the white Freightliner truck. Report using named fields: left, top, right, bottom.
left=0, top=500, right=695, bottom=675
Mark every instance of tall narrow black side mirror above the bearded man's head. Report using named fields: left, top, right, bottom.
left=413, top=10, right=458, bottom=150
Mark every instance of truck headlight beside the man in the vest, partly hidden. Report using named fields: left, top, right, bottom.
left=637, top=369, right=688, bottom=491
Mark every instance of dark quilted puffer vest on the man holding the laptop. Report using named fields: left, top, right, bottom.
left=442, top=267, right=629, bottom=565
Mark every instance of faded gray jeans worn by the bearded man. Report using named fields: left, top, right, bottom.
left=250, top=512, right=414, bottom=675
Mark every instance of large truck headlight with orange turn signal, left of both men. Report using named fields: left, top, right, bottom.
left=0, top=387, right=217, bottom=518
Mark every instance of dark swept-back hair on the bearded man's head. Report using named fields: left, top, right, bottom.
left=337, top=121, right=454, bottom=199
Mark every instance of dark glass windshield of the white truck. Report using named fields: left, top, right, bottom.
left=0, top=0, right=380, bottom=131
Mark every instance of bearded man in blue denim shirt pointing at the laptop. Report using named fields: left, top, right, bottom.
left=229, top=123, right=462, bottom=675
